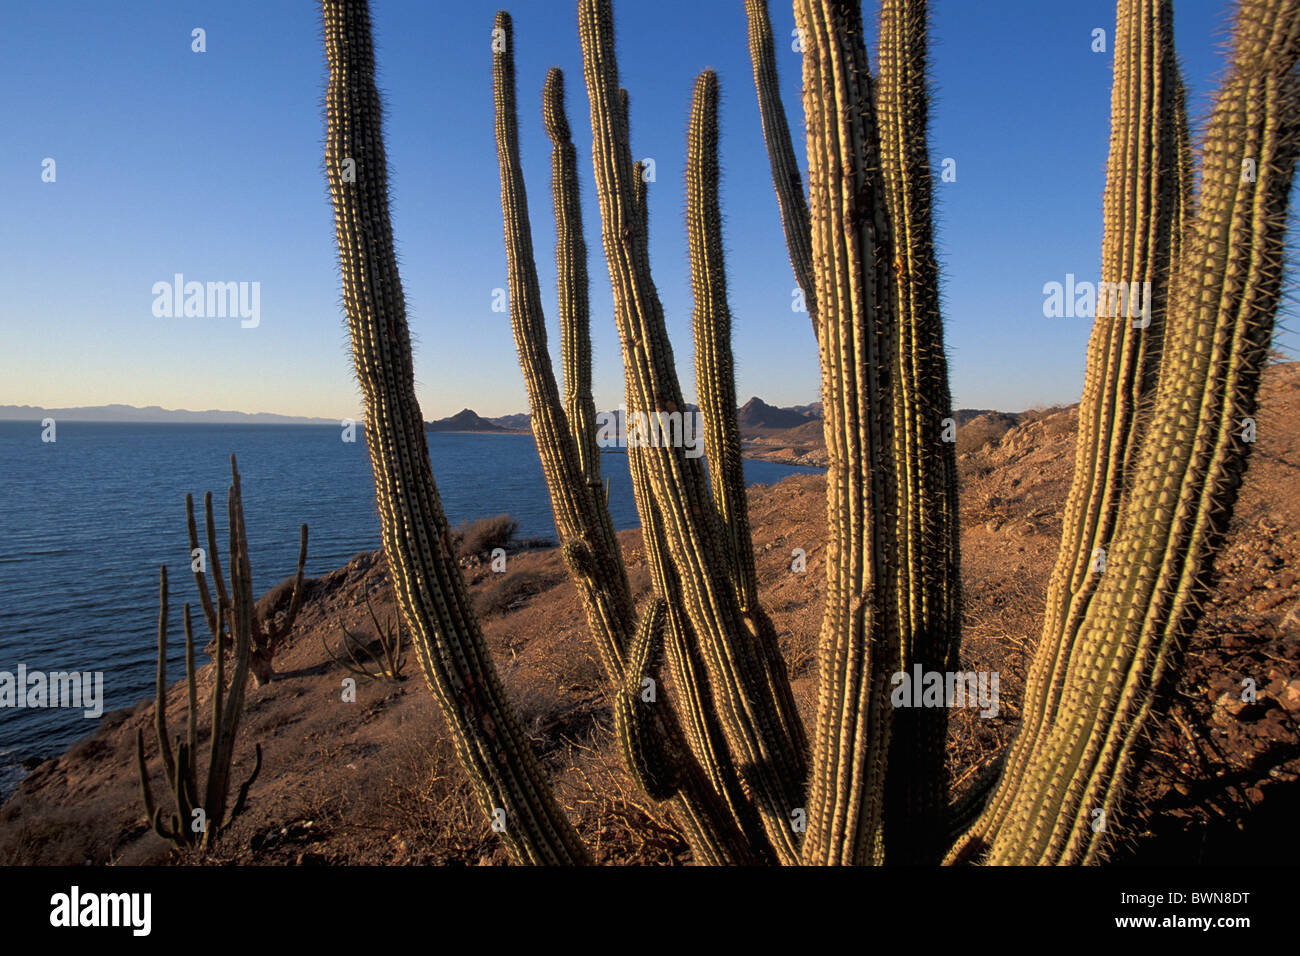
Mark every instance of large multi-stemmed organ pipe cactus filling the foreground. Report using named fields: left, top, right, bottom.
left=324, top=0, right=1300, bottom=864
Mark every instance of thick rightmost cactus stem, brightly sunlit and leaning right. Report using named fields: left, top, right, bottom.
left=953, top=0, right=1300, bottom=864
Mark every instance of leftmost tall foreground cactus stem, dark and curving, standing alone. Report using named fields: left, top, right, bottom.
left=322, top=0, right=590, bottom=864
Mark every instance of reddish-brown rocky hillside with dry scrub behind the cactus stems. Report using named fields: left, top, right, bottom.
left=0, top=363, right=1300, bottom=865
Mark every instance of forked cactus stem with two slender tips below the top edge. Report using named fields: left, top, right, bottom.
left=493, top=12, right=754, bottom=864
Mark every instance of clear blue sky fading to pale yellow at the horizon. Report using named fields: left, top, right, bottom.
left=0, top=0, right=1295, bottom=419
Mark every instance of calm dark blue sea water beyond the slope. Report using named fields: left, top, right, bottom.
left=0, top=421, right=818, bottom=788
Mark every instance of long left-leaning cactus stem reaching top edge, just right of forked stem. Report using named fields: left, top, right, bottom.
left=579, top=0, right=805, bottom=860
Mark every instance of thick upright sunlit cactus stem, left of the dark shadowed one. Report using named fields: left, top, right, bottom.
left=794, top=0, right=901, bottom=865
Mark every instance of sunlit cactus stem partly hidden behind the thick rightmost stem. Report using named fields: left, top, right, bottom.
left=956, top=0, right=1191, bottom=858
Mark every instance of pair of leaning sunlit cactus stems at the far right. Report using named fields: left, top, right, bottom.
left=950, top=0, right=1300, bottom=864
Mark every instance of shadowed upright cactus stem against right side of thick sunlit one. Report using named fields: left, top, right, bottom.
left=876, top=0, right=962, bottom=862
